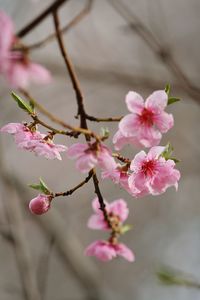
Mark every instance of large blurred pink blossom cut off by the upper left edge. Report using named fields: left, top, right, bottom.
left=0, top=11, right=51, bottom=88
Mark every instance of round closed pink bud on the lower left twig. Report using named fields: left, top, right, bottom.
left=29, top=194, right=52, bottom=215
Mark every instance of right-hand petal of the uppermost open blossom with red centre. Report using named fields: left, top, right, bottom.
left=154, top=111, right=174, bottom=133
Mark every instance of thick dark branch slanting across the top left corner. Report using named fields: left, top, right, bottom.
left=16, top=0, right=69, bottom=38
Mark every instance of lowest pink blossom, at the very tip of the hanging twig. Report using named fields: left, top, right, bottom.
left=85, top=240, right=135, bottom=262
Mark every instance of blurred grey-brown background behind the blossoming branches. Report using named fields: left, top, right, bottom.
left=0, top=0, right=200, bottom=300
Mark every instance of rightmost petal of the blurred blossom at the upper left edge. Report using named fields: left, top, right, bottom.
left=28, top=63, right=52, bottom=83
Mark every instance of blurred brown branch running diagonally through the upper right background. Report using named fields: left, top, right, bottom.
left=107, top=0, right=200, bottom=103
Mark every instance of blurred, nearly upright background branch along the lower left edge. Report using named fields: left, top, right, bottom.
left=0, top=142, right=40, bottom=300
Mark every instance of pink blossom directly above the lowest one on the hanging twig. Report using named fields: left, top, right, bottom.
left=88, top=197, right=129, bottom=230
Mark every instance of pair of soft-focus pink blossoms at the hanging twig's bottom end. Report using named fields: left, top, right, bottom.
left=85, top=198, right=135, bottom=262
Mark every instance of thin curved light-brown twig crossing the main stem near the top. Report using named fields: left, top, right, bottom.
left=27, top=0, right=93, bottom=50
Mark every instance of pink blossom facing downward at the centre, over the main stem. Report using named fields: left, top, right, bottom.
left=67, top=143, right=115, bottom=173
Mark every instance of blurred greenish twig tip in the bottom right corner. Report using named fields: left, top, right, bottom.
left=157, top=266, right=200, bottom=289
